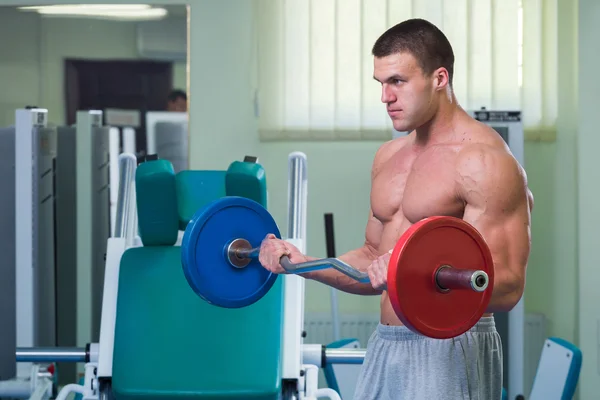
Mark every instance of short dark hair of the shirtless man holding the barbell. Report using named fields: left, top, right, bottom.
left=373, top=18, right=454, bottom=86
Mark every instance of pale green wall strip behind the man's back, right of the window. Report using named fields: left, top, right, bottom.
left=525, top=0, right=578, bottom=343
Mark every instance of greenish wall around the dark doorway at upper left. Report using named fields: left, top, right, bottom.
left=0, top=7, right=187, bottom=126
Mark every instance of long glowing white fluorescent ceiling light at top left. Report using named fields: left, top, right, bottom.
left=20, top=4, right=168, bottom=20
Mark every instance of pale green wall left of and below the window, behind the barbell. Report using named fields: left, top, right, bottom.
left=184, top=0, right=379, bottom=313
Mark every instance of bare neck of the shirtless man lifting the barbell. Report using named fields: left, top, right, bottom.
left=415, top=95, right=464, bottom=145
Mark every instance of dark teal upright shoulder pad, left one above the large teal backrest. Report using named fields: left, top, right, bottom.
left=135, top=160, right=179, bottom=246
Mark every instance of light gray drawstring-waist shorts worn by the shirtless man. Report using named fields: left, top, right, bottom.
left=354, top=317, right=502, bottom=400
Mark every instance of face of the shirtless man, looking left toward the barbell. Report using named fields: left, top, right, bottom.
left=373, top=53, right=435, bottom=132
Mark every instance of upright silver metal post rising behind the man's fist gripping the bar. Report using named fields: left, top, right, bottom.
left=288, top=152, right=307, bottom=241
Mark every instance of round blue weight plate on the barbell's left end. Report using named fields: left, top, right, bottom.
left=181, top=196, right=281, bottom=308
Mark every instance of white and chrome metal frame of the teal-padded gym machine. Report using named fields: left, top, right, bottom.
left=16, top=153, right=364, bottom=400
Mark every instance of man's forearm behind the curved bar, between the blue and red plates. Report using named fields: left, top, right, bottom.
left=301, top=247, right=381, bottom=296
